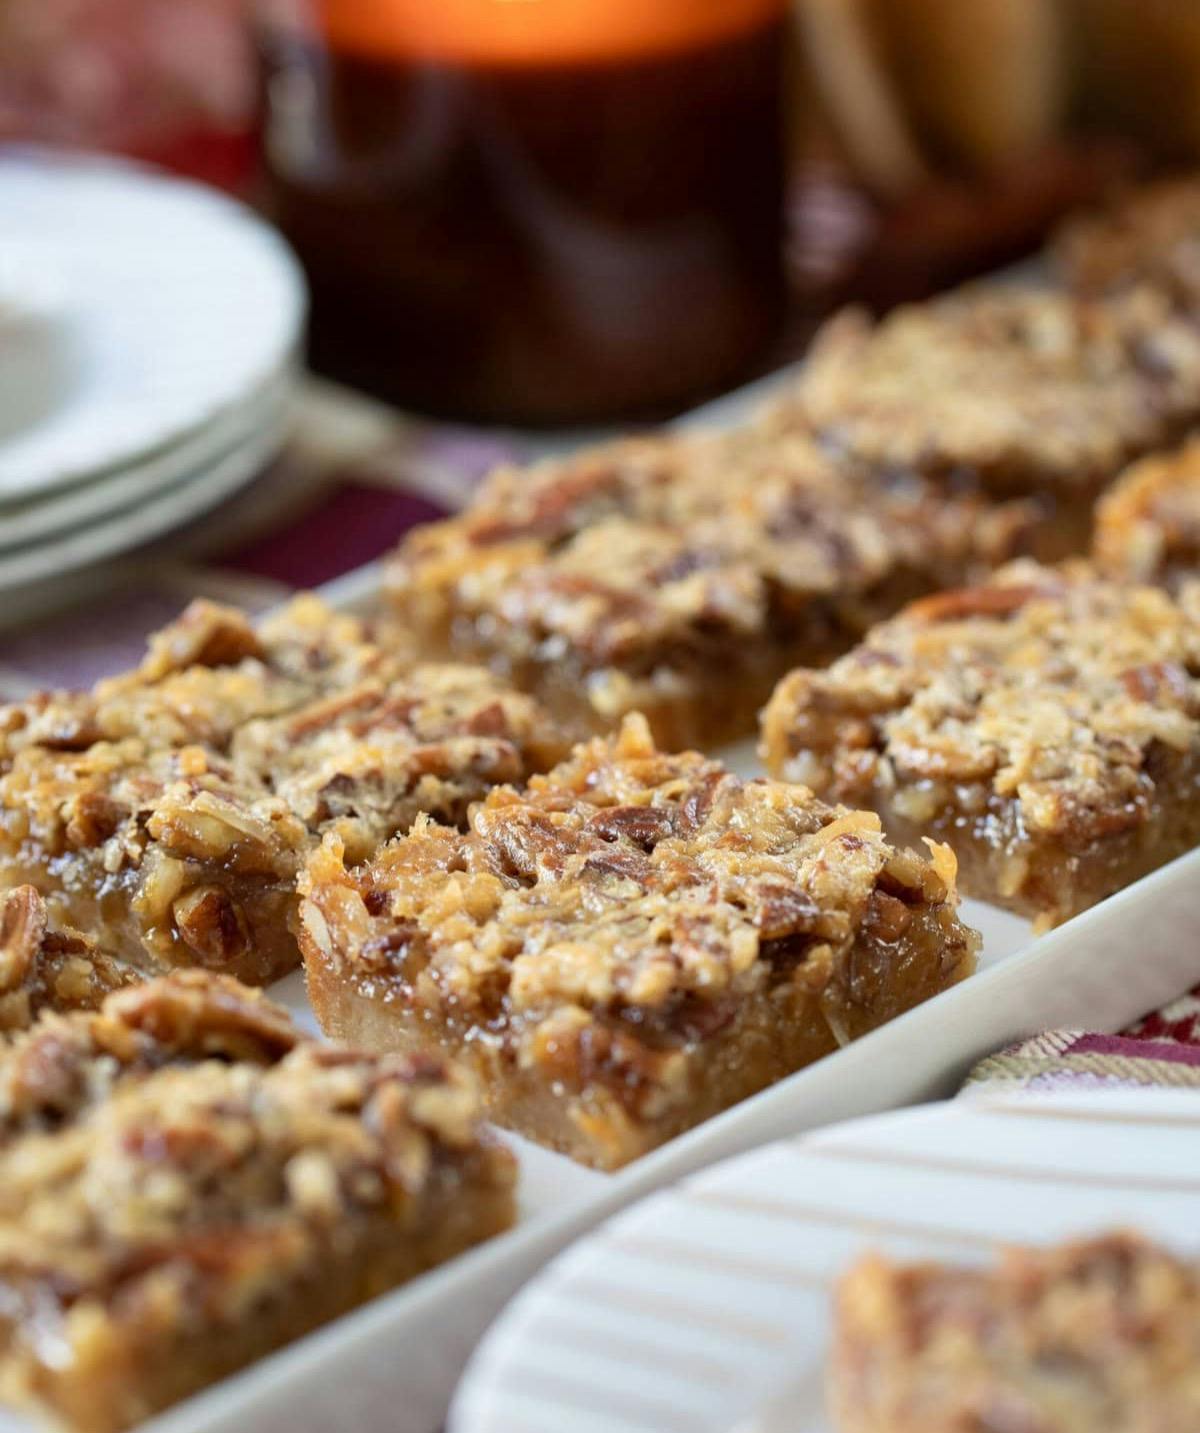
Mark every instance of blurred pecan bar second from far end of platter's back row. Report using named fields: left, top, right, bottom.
left=776, top=287, right=1200, bottom=560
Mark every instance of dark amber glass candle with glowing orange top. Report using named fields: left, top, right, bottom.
left=262, top=0, right=784, bottom=421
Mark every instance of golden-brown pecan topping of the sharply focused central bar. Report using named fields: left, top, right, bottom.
left=301, top=718, right=971, bottom=1077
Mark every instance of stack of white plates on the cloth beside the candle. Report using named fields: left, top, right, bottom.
left=0, top=149, right=305, bottom=595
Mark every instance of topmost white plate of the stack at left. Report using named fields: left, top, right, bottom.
left=0, top=149, right=305, bottom=504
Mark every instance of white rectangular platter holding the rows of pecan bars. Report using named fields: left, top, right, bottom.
left=93, top=372, right=1200, bottom=1433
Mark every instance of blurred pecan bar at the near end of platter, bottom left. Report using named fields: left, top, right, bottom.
left=0, top=970, right=513, bottom=1433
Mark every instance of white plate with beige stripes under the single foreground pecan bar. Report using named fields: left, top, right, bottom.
left=450, top=1089, right=1200, bottom=1433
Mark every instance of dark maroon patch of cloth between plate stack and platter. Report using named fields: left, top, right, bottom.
left=216, top=483, right=446, bottom=588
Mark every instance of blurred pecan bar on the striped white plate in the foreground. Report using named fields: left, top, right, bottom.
left=830, top=1234, right=1200, bottom=1433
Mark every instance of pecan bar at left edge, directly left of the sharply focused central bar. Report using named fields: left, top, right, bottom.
left=0, top=598, right=562, bottom=983
